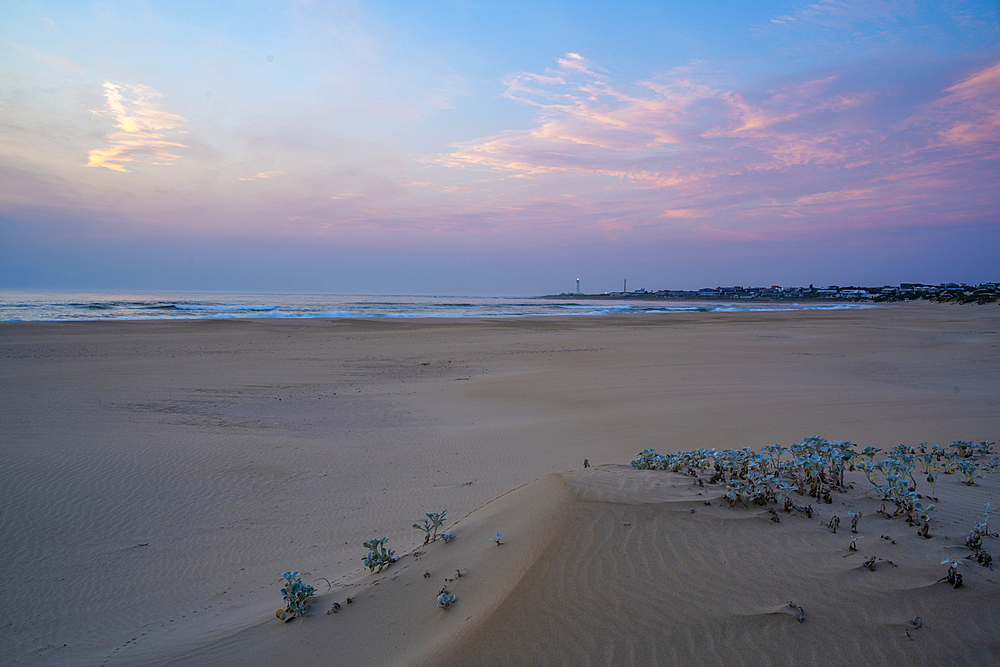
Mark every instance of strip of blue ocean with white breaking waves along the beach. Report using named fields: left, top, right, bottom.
left=0, top=290, right=875, bottom=322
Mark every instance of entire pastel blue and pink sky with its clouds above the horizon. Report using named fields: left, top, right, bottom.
left=0, top=0, right=1000, bottom=295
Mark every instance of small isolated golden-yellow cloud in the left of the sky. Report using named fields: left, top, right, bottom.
left=85, top=81, right=187, bottom=172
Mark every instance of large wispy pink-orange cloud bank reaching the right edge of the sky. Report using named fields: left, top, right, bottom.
left=437, top=54, right=1000, bottom=238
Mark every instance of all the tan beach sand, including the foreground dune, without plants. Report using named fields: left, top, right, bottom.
left=0, top=303, right=1000, bottom=665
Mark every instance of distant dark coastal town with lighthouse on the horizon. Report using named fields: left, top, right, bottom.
left=543, top=281, right=1000, bottom=304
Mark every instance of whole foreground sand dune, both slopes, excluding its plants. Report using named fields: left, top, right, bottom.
left=162, top=465, right=1000, bottom=665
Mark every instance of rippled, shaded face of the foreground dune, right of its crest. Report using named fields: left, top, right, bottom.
left=429, top=467, right=1000, bottom=665
